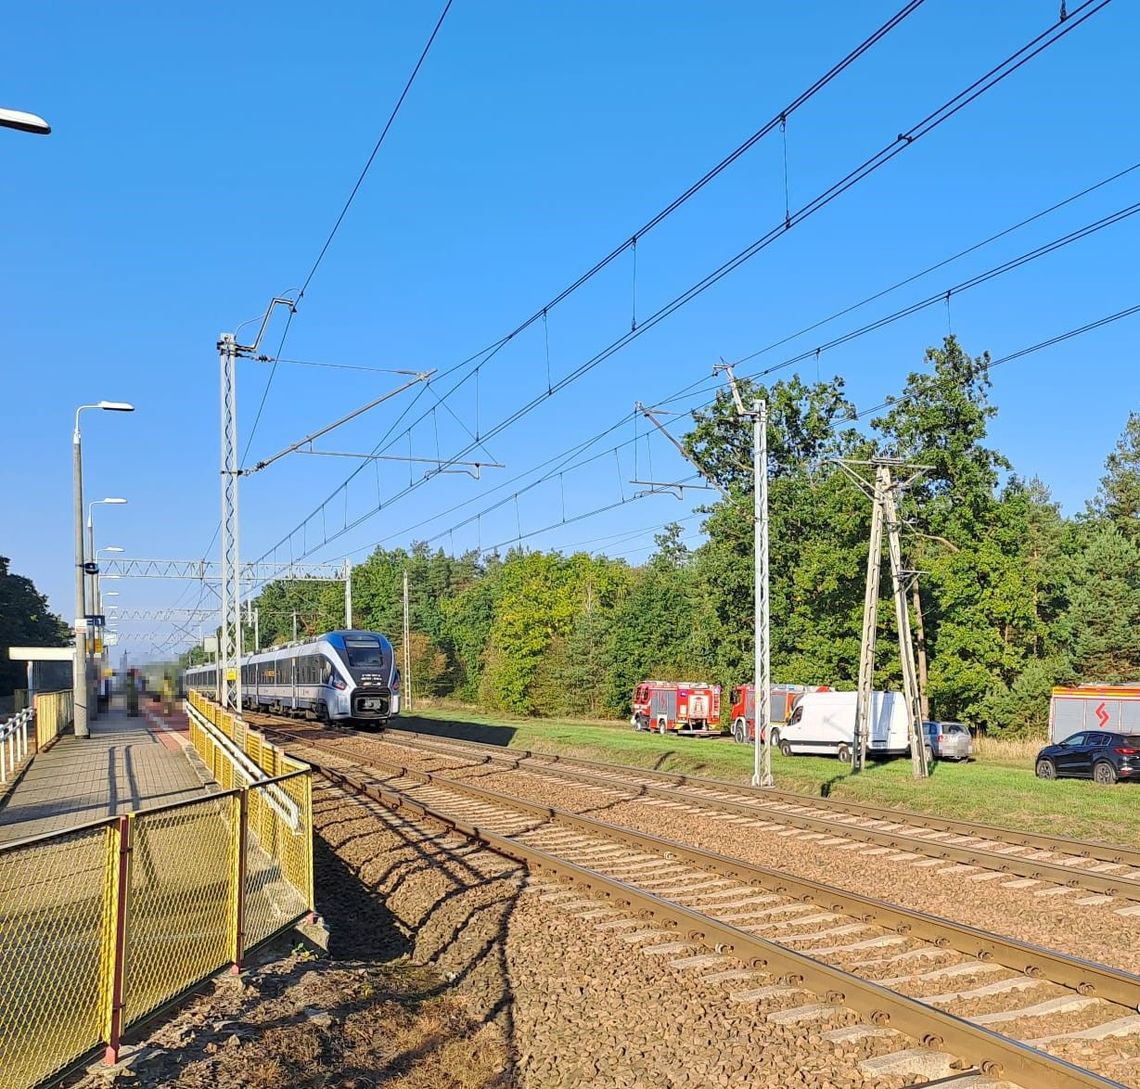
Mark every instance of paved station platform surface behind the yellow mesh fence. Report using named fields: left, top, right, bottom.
left=0, top=700, right=217, bottom=843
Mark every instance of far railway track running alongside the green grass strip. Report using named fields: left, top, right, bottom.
left=342, top=716, right=1140, bottom=913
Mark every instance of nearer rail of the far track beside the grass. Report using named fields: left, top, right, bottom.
left=355, top=729, right=1140, bottom=901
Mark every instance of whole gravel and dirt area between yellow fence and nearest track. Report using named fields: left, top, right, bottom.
left=64, top=785, right=913, bottom=1089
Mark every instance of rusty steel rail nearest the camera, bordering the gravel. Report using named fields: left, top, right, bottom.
left=307, top=742, right=1119, bottom=1089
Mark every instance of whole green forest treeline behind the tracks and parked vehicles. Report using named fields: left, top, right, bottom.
left=222, top=338, right=1140, bottom=737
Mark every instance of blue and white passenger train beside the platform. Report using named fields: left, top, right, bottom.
left=184, top=632, right=400, bottom=729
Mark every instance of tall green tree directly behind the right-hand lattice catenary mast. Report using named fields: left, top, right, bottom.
left=685, top=377, right=870, bottom=684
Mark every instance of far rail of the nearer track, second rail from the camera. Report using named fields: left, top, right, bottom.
left=264, top=731, right=1140, bottom=1011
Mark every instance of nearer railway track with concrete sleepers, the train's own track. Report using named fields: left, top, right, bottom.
left=256, top=723, right=1140, bottom=1089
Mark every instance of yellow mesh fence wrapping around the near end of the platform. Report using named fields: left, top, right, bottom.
left=0, top=697, right=312, bottom=1089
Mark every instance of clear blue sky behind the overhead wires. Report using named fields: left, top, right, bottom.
left=0, top=0, right=1140, bottom=653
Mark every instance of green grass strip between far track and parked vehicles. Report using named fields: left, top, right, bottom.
left=398, top=707, right=1140, bottom=845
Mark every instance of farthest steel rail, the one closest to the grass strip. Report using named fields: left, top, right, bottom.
left=388, top=726, right=1140, bottom=869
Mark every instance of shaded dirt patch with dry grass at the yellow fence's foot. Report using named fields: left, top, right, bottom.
left=61, top=789, right=515, bottom=1089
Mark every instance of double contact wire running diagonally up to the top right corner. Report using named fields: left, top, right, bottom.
left=262, top=0, right=1112, bottom=570
